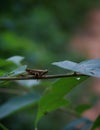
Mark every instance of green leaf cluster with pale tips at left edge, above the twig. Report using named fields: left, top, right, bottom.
left=0, top=56, right=24, bottom=76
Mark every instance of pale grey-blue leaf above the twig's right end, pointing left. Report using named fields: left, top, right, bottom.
left=52, top=59, right=100, bottom=78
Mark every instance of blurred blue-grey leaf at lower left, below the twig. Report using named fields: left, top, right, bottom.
left=0, top=94, right=40, bottom=119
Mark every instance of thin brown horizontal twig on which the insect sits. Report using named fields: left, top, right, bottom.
left=0, top=73, right=86, bottom=80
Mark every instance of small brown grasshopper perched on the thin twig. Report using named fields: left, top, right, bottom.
left=26, top=68, right=48, bottom=77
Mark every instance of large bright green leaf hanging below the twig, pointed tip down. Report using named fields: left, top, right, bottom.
left=36, top=76, right=87, bottom=125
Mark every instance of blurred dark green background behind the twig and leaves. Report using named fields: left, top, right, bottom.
left=0, top=0, right=100, bottom=130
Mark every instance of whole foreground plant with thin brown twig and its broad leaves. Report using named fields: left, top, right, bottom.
left=0, top=56, right=100, bottom=130
